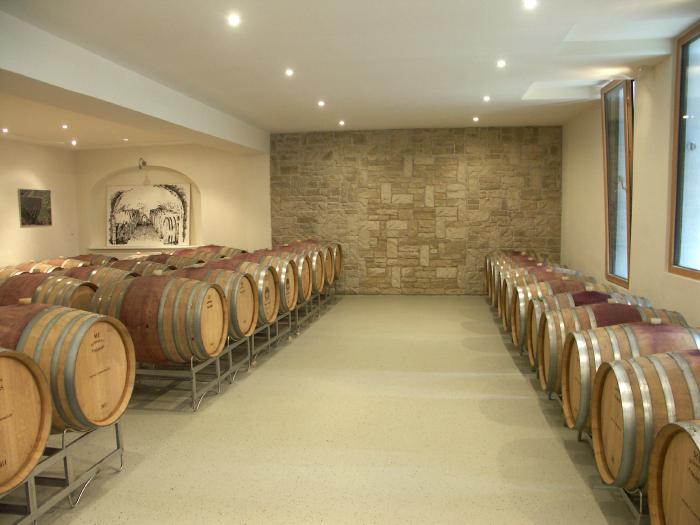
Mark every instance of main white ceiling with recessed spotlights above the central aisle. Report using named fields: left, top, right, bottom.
left=0, top=0, right=700, bottom=132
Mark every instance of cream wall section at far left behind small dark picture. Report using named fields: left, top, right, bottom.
left=0, top=139, right=78, bottom=266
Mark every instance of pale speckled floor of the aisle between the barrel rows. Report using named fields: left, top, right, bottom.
left=16, top=296, right=632, bottom=525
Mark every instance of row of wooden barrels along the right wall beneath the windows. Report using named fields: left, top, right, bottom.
left=484, top=251, right=700, bottom=524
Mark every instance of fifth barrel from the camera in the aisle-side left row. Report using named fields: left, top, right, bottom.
left=206, top=255, right=280, bottom=326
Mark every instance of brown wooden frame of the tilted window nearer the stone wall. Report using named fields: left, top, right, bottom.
left=600, top=80, right=634, bottom=288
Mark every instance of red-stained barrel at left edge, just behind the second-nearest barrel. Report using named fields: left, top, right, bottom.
left=0, top=273, right=97, bottom=310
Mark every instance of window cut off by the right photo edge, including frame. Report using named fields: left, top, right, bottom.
left=670, top=25, right=700, bottom=279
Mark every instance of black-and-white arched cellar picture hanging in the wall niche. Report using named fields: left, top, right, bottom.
left=107, top=184, right=191, bottom=248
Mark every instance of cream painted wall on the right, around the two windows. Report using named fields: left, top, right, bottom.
left=562, top=58, right=700, bottom=326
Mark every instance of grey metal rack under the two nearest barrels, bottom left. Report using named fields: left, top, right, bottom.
left=0, top=421, right=124, bottom=525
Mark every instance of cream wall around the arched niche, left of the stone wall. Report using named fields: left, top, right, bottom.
left=77, top=145, right=271, bottom=256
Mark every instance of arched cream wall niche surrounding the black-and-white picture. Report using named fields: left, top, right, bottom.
left=88, top=165, right=202, bottom=251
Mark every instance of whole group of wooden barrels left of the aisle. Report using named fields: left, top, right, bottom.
left=0, top=242, right=342, bottom=494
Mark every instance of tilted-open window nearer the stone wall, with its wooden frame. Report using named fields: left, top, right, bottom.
left=602, top=80, right=634, bottom=286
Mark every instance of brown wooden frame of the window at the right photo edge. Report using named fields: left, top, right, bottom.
left=668, top=23, right=700, bottom=280
